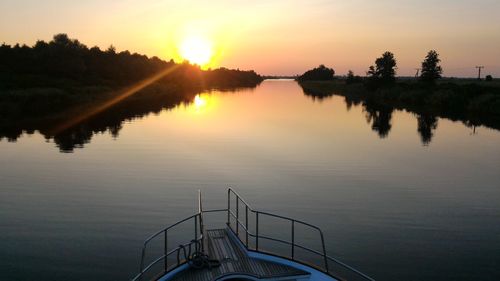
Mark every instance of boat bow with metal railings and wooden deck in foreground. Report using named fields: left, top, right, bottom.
left=132, top=188, right=374, bottom=281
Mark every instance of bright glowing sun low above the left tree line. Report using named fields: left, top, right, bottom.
left=179, top=36, right=213, bottom=66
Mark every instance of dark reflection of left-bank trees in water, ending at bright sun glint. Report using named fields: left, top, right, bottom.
left=0, top=85, right=250, bottom=152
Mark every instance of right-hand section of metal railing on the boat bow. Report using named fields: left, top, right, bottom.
left=227, top=188, right=374, bottom=281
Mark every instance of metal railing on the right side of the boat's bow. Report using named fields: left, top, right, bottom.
left=227, top=188, right=374, bottom=281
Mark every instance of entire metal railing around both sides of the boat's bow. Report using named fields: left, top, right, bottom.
left=132, top=188, right=374, bottom=281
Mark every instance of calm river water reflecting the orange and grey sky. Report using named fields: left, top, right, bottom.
left=0, top=81, right=500, bottom=281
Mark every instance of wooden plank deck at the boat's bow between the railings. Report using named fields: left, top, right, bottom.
left=172, top=229, right=309, bottom=281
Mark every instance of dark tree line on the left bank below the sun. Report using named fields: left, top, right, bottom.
left=0, top=34, right=262, bottom=89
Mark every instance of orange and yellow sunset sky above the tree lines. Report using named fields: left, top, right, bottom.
left=0, top=0, right=500, bottom=77
